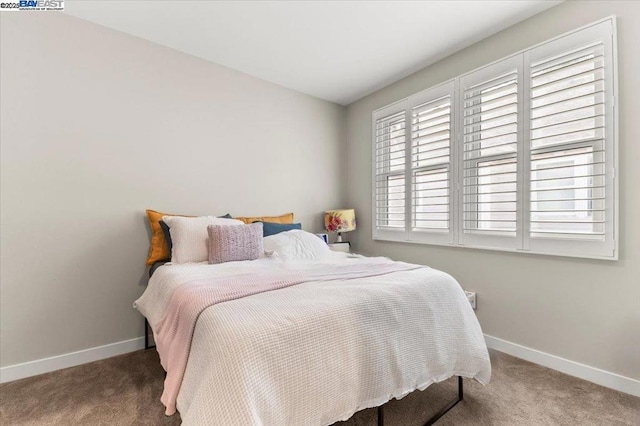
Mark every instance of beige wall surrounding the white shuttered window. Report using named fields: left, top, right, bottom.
left=347, top=1, right=640, bottom=379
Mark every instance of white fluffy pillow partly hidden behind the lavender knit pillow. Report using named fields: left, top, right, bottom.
left=162, top=216, right=244, bottom=263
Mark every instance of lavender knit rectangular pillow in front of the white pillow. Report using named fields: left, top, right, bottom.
left=207, top=222, right=264, bottom=263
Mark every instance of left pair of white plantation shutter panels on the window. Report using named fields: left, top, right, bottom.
left=373, top=82, right=455, bottom=244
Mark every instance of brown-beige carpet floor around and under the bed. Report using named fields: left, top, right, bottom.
left=0, top=350, right=640, bottom=426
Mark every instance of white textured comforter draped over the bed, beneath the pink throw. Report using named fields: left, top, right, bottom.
left=135, top=253, right=491, bottom=426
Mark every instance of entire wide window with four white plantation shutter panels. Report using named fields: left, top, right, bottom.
left=373, top=18, right=617, bottom=259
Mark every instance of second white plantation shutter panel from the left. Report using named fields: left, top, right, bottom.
left=409, top=81, right=455, bottom=244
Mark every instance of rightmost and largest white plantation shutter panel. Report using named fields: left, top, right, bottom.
left=527, top=22, right=614, bottom=257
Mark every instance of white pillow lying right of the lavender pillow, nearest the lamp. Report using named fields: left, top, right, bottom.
left=264, top=229, right=331, bottom=260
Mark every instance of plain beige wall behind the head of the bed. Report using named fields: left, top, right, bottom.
left=0, top=12, right=345, bottom=366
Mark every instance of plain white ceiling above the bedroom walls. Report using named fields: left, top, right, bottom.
left=65, top=0, right=560, bottom=105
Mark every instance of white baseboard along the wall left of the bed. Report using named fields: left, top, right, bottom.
left=0, top=337, right=144, bottom=383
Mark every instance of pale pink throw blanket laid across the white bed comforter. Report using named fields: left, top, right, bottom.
left=154, top=262, right=422, bottom=416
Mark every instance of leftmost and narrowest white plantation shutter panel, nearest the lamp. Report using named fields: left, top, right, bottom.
left=373, top=102, right=408, bottom=239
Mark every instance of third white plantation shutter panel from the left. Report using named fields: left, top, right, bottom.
left=459, top=57, right=522, bottom=249
